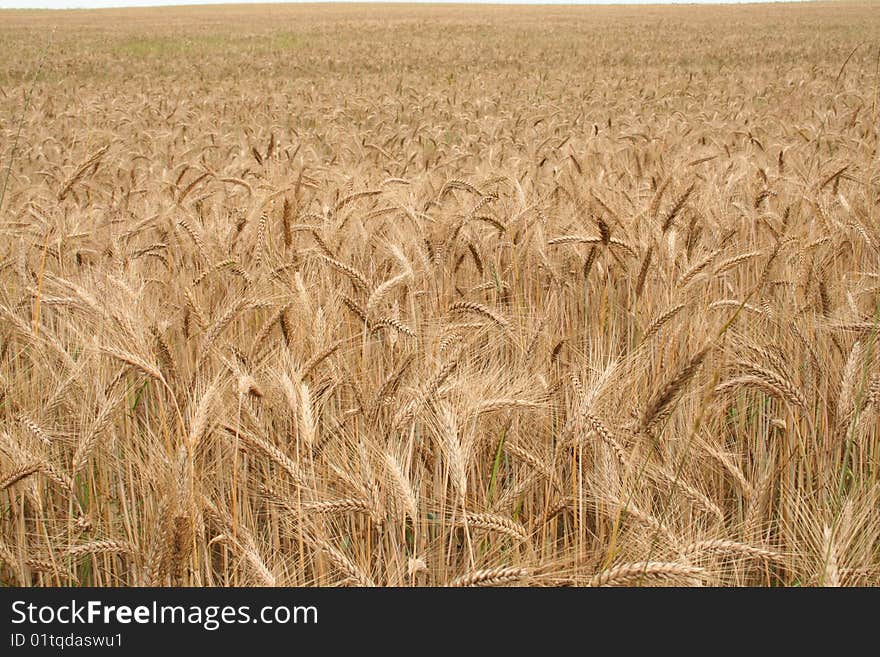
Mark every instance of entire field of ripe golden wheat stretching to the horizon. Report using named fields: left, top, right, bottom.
left=0, top=3, right=880, bottom=586
